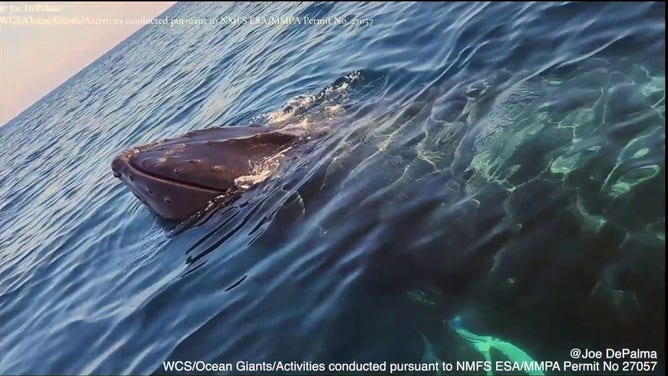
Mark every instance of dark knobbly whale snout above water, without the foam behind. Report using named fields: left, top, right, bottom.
left=111, top=126, right=298, bottom=220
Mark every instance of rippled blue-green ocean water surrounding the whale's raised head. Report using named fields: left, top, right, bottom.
left=0, top=2, right=665, bottom=375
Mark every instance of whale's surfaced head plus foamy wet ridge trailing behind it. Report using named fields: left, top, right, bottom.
left=111, top=71, right=361, bottom=220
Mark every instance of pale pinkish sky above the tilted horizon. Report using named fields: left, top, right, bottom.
left=0, top=1, right=175, bottom=126
